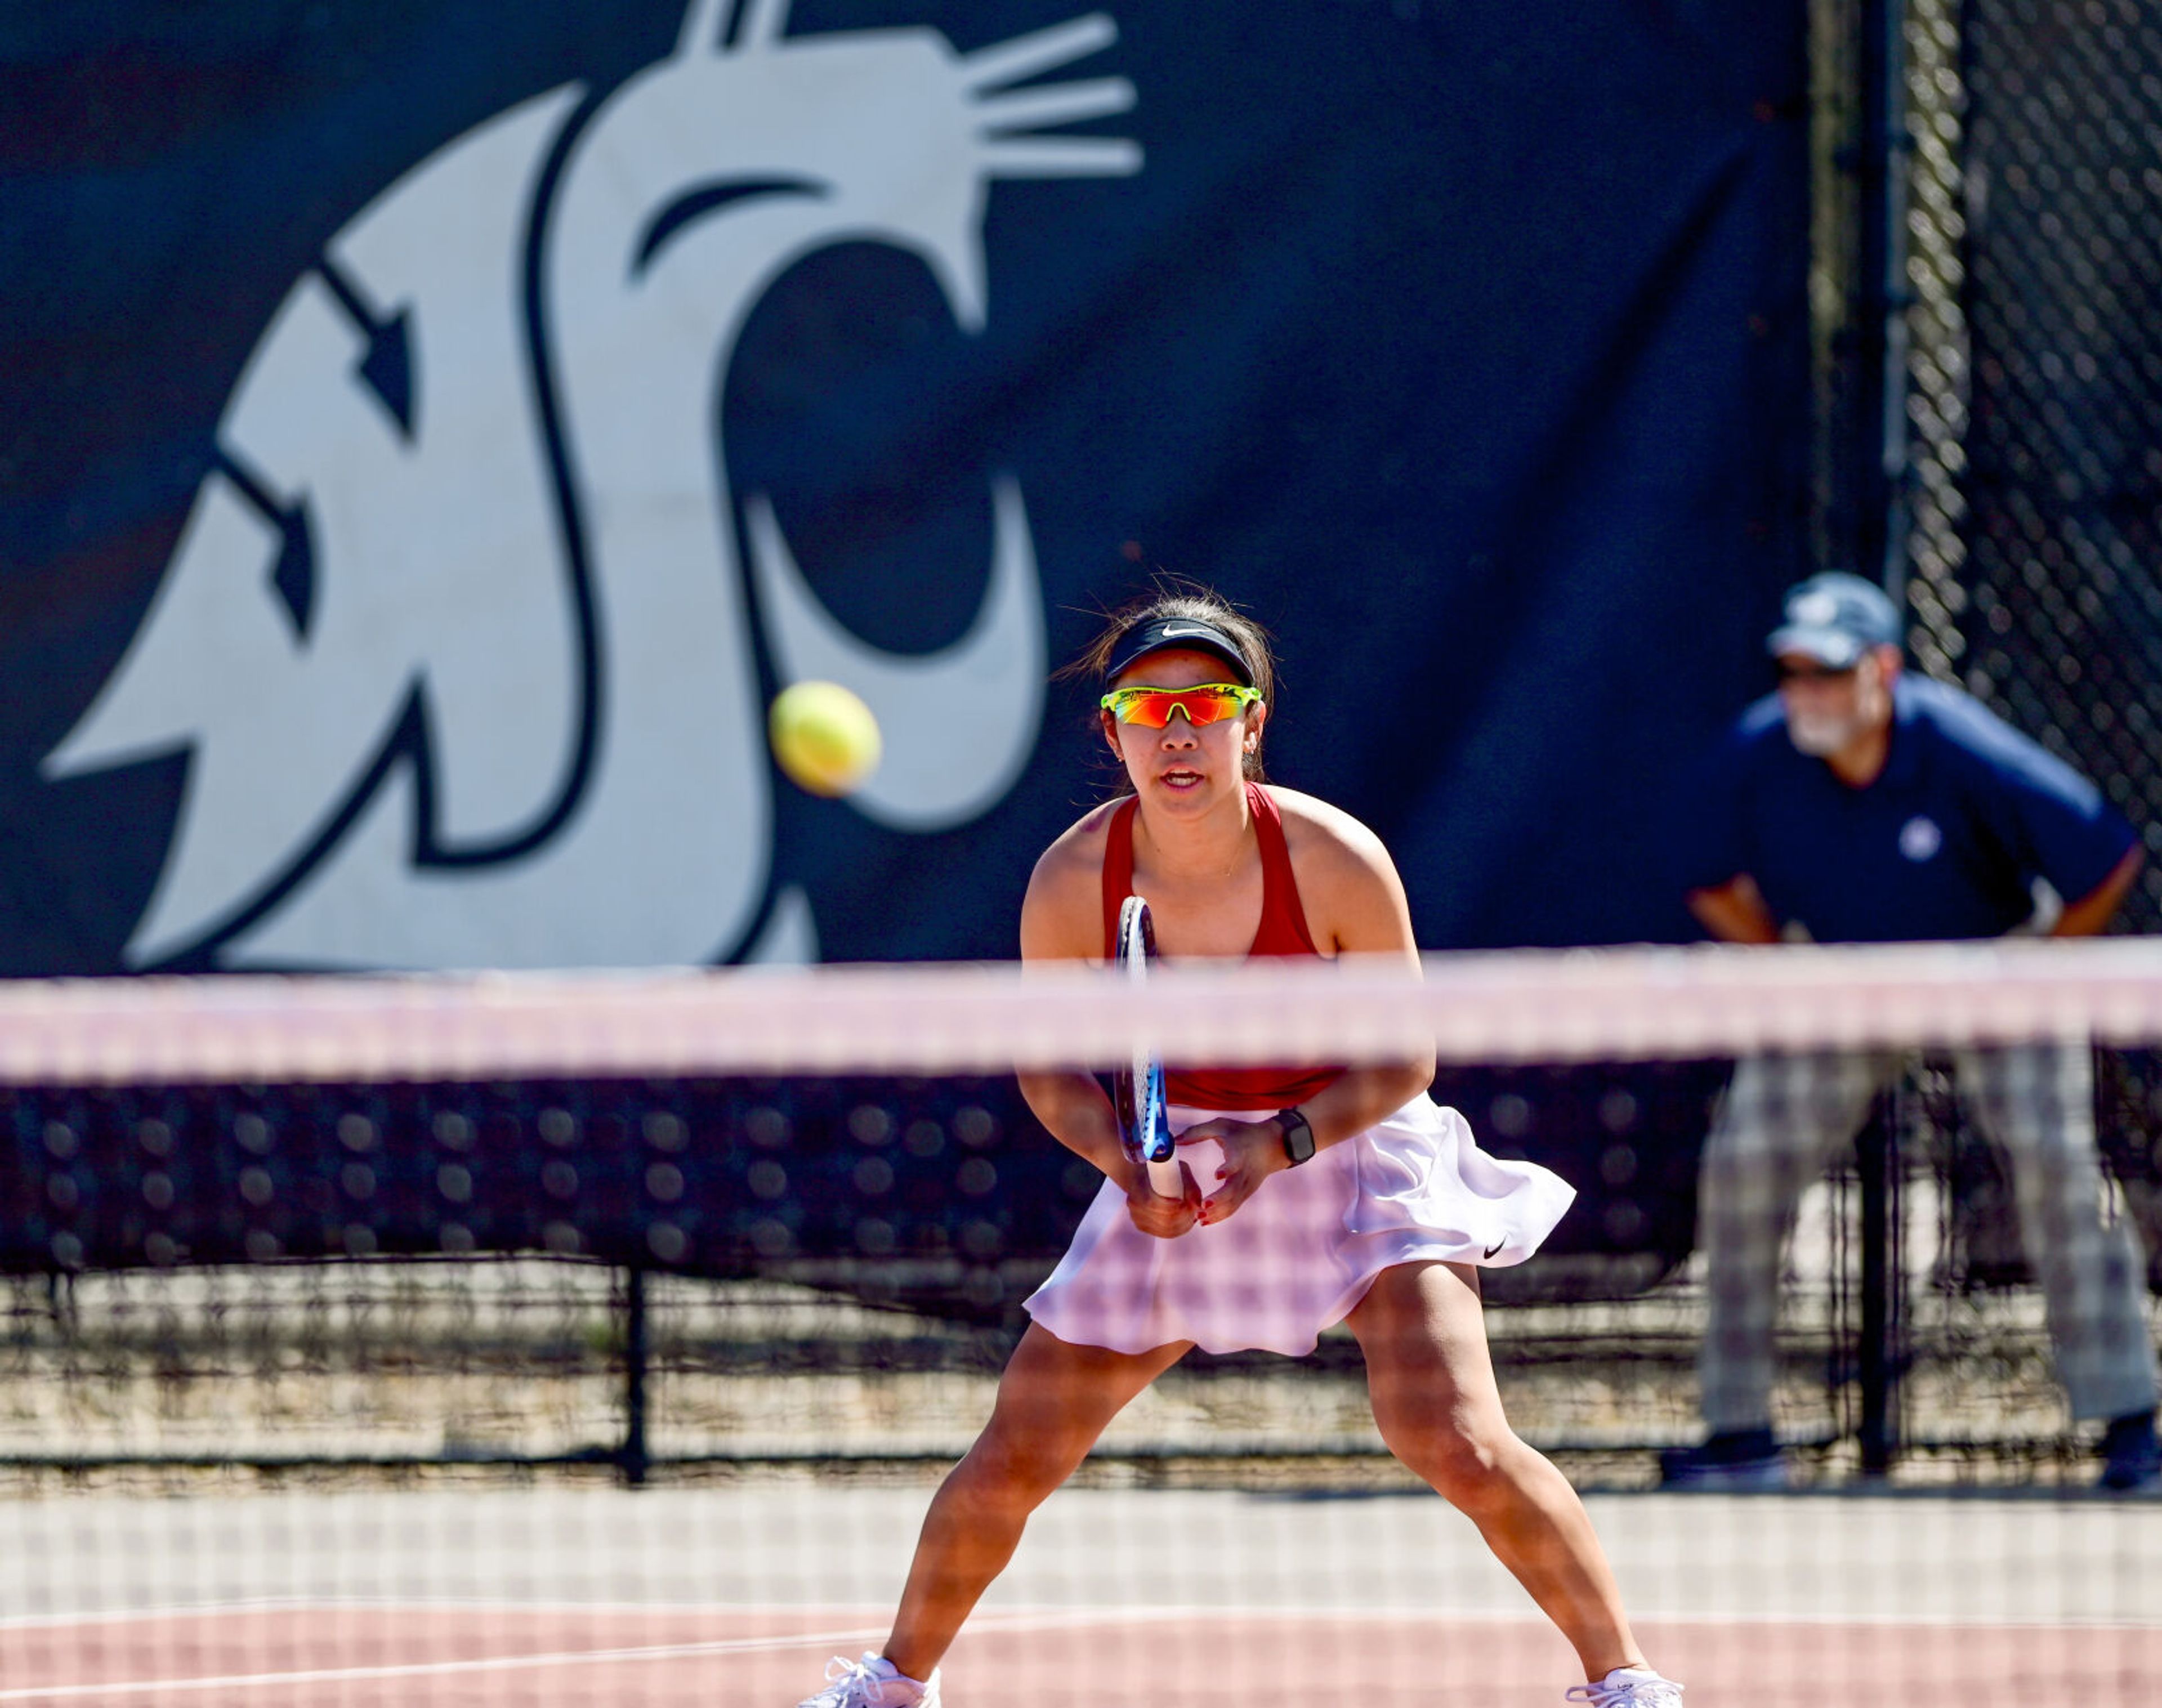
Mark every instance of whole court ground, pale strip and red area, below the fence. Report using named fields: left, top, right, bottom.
left=0, top=1481, right=2162, bottom=1708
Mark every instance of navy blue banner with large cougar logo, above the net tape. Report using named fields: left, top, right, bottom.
left=0, top=0, right=1807, bottom=973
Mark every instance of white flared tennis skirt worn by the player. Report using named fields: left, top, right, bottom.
left=1027, top=1094, right=1576, bottom=1358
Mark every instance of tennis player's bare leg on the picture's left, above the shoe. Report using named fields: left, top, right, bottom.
left=886, top=1323, right=1189, bottom=1678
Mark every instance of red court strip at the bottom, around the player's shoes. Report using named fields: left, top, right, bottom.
left=0, top=1606, right=2162, bottom=1708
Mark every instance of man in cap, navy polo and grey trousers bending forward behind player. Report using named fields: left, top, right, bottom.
left=1665, top=573, right=2162, bottom=1490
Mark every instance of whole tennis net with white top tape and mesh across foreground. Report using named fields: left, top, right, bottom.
left=0, top=938, right=2162, bottom=1708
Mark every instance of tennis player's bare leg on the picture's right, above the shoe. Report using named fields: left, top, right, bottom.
left=1349, top=1263, right=1643, bottom=1680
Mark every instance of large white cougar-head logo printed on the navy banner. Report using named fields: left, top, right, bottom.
left=46, top=0, right=1142, bottom=967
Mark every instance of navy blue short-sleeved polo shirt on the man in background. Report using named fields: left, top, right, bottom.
left=1688, top=674, right=2136, bottom=942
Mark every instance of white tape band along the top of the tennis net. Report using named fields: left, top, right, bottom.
left=0, top=938, right=2162, bottom=1085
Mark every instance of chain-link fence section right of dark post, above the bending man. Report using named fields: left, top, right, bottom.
left=1905, top=0, right=2162, bottom=932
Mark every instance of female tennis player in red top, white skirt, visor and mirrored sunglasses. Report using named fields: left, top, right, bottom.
left=800, top=590, right=1682, bottom=1708
